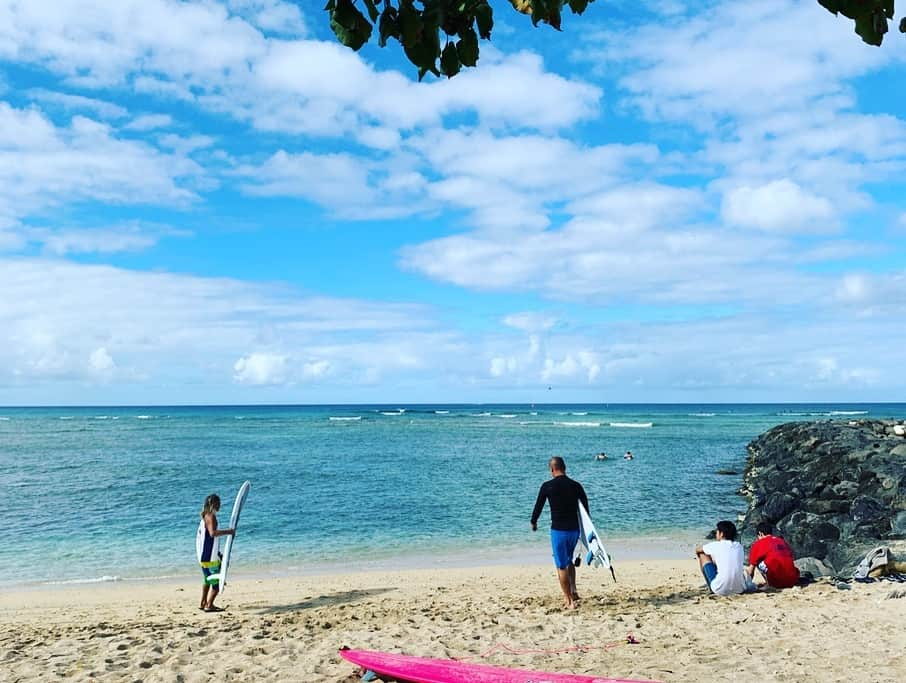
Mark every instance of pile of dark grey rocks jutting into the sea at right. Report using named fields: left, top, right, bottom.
left=740, top=420, right=906, bottom=576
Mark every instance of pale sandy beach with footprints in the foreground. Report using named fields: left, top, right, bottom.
left=0, top=558, right=906, bottom=683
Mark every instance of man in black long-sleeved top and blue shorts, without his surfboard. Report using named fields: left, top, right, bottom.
left=532, top=455, right=588, bottom=609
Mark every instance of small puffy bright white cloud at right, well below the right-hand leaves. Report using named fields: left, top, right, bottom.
left=721, top=178, right=835, bottom=232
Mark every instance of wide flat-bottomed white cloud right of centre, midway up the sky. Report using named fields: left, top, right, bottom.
left=401, top=184, right=800, bottom=304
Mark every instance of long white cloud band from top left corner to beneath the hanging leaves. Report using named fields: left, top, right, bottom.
left=0, top=0, right=601, bottom=148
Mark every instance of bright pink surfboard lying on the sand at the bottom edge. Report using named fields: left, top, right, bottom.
left=340, top=648, right=655, bottom=683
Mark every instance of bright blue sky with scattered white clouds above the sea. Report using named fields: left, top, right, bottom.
left=0, top=0, right=906, bottom=405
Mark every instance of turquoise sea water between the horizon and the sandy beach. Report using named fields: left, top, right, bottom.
left=0, top=404, right=906, bottom=585
